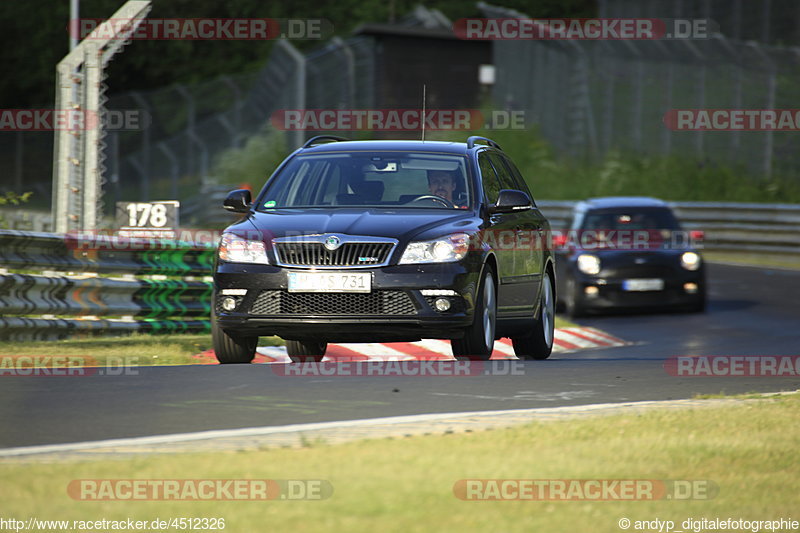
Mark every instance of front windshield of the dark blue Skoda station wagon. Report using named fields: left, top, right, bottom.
left=258, top=152, right=472, bottom=211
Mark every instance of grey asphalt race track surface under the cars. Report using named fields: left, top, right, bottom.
left=0, top=264, right=800, bottom=448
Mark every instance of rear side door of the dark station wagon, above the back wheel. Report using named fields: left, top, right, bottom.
left=490, top=153, right=545, bottom=310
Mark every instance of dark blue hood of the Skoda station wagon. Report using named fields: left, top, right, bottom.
left=228, top=208, right=481, bottom=242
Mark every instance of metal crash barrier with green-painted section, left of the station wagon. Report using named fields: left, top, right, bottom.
left=0, top=230, right=214, bottom=340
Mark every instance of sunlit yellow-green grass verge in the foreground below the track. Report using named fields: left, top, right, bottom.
left=0, top=394, right=800, bottom=533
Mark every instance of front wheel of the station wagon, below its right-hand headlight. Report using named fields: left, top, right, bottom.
left=450, top=268, right=497, bottom=361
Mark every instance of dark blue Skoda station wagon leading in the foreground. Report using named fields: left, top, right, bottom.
left=212, top=136, right=556, bottom=363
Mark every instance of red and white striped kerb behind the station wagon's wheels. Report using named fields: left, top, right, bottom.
left=194, top=327, right=630, bottom=364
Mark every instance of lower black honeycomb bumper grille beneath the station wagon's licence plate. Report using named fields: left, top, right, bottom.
left=250, top=290, right=417, bottom=315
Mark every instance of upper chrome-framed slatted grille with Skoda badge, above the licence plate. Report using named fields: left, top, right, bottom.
left=275, top=242, right=394, bottom=266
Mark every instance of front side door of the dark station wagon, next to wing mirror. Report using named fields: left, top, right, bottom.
left=478, top=150, right=525, bottom=314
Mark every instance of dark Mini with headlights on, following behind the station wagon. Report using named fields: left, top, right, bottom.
left=554, top=197, right=706, bottom=317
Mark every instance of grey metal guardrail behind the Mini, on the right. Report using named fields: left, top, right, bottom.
left=537, top=201, right=800, bottom=258
